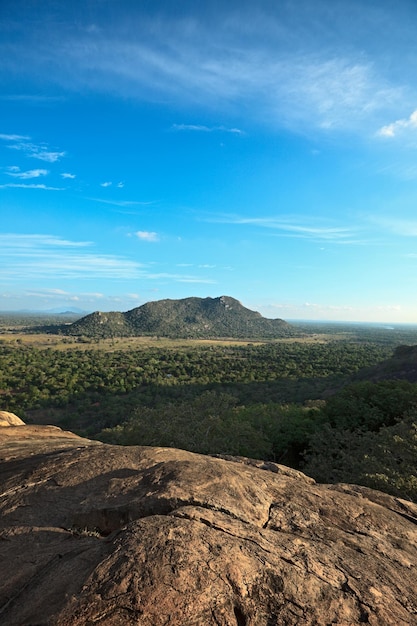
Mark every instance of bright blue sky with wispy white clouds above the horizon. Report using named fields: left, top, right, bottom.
left=0, top=0, right=417, bottom=323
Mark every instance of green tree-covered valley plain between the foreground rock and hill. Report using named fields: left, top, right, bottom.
left=0, top=308, right=417, bottom=500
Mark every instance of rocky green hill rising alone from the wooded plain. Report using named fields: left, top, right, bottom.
left=64, top=296, right=293, bottom=339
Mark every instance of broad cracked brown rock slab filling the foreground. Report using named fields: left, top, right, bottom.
left=0, top=425, right=417, bottom=626
